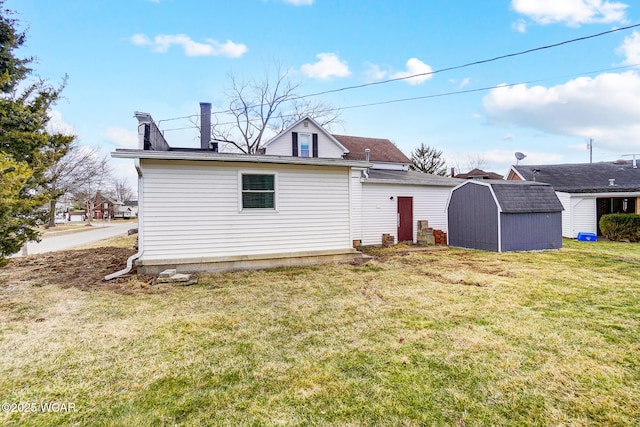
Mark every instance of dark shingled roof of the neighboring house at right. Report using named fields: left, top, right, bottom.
left=513, top=161, right=640, bottom=193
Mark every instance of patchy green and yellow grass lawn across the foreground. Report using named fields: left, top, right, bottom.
left=0, top=240, right=640, bottom=426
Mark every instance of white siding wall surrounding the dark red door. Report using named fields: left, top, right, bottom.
left=354, top=182, right=451, bottom=245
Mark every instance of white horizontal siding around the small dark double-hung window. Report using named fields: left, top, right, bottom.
left=141, top=160, right=351, bottom=262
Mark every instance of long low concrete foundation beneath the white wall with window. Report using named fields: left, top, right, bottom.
left=137, top=248, right=363, bottom=275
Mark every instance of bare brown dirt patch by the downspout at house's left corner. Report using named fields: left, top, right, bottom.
left=0, top=247, right=161, bottom=295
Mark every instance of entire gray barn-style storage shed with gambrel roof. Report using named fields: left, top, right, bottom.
left=447, top=180, right=563, bottom=252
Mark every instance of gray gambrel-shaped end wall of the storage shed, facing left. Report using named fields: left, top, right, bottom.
left=447, top=185, right=498, bottom=252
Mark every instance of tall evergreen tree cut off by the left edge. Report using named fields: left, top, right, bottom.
left=0, top=0, right=74, bottom=266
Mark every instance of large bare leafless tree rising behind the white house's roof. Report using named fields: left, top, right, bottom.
left=212, top=63, right=340, bottom=154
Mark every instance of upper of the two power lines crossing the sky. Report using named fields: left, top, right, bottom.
left=157, top=24, right=640, bottom=124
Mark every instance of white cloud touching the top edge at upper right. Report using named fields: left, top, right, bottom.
left=511, top=0, right=629, bottom=27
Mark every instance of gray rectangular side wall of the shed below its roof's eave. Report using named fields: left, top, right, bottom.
left=500, top=212, right=562, bottom=252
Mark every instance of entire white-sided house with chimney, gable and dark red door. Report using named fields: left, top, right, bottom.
left=112, top=113, right=460, bottom=274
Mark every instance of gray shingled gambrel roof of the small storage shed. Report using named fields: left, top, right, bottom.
left=488, top=180, right=563, bottom=213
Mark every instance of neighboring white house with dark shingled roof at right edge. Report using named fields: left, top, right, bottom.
left=507, top=160, right=640, bottom=238
